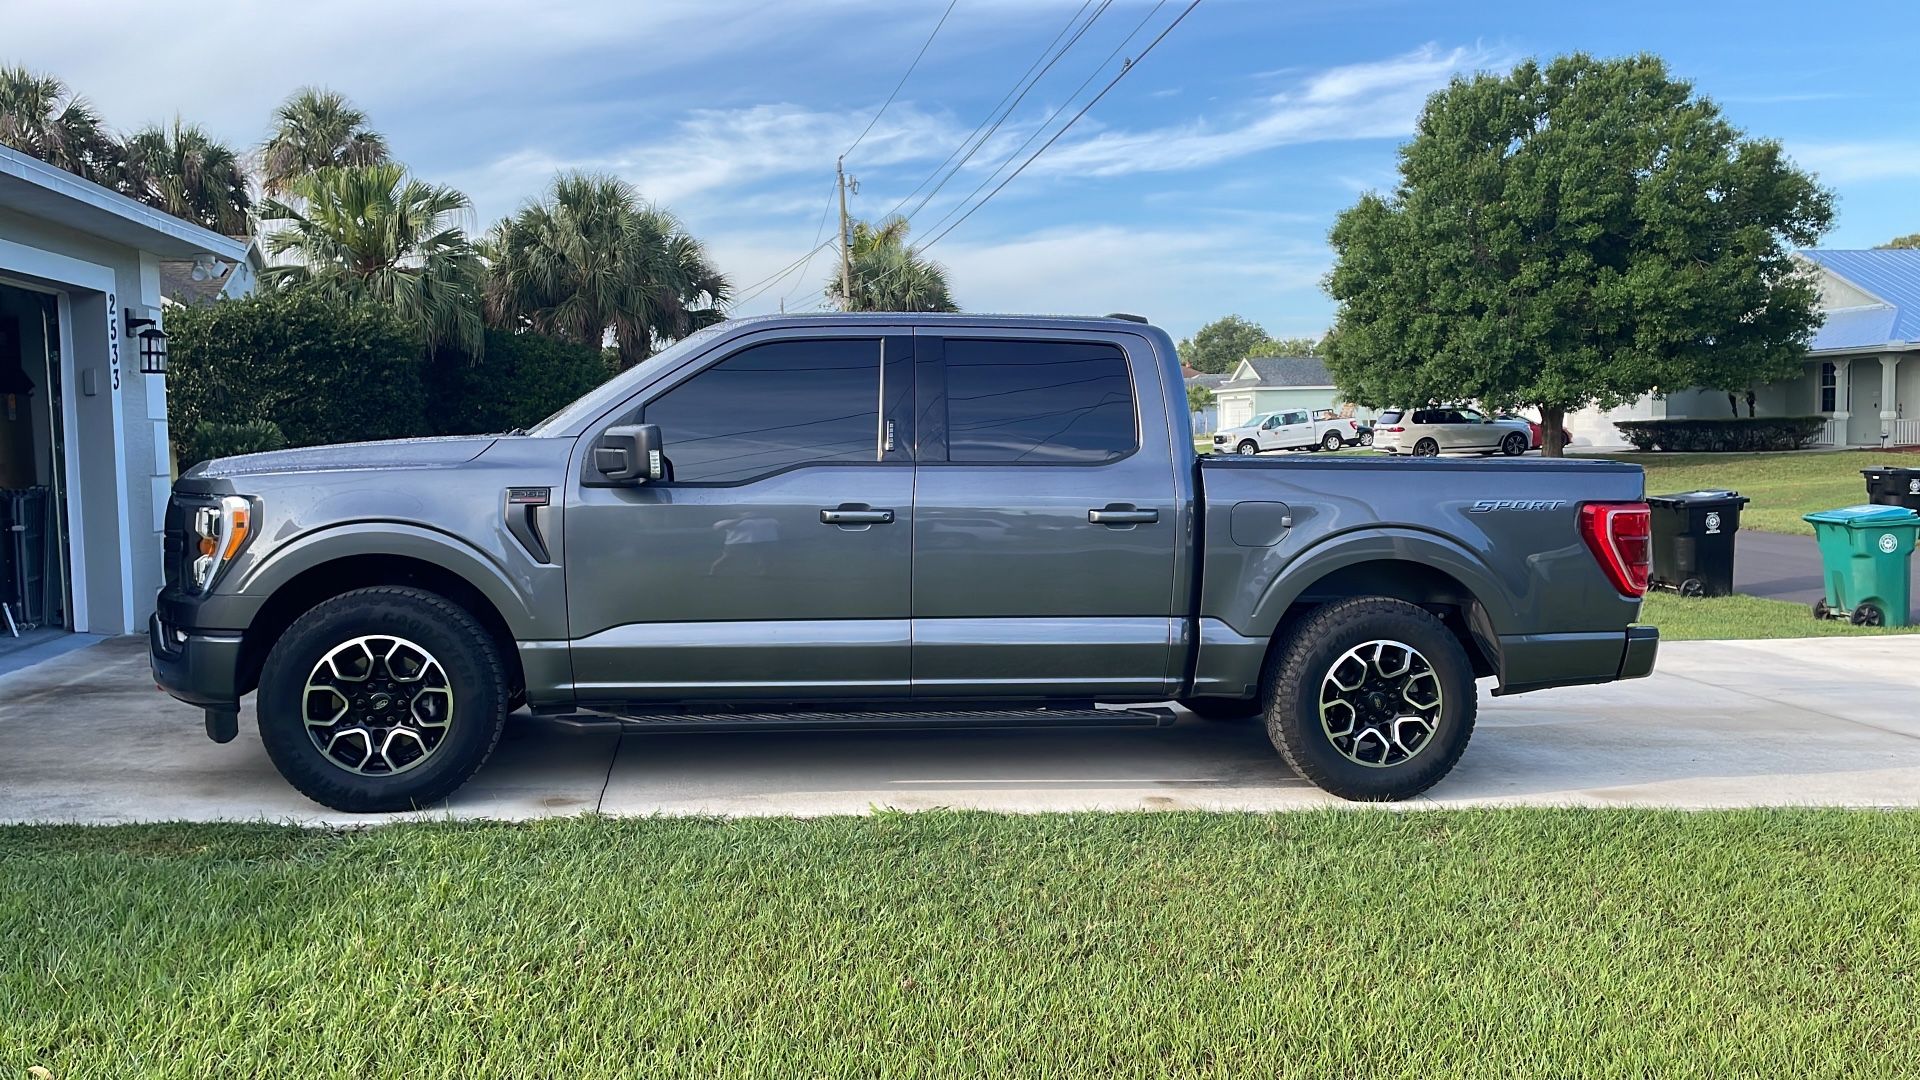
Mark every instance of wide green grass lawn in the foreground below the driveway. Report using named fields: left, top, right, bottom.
left=0, top=811, right=1920, bottom=1080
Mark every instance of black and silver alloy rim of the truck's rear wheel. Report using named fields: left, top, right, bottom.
left=1319, top=640, right=1446, bottom=769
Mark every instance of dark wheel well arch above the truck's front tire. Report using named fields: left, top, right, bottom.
left=240, top=555, right=526, bottom=698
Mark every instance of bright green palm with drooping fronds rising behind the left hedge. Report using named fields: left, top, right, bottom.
left=261, top=163, right=484, bottom=356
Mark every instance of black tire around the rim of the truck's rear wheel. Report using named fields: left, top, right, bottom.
left=1260, top=596, right=1478, bottom=801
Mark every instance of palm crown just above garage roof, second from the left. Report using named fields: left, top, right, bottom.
left=121, top=117, right=253, bottom=234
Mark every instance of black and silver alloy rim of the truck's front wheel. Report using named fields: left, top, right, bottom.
left=301, top=634, right=453, bottom=776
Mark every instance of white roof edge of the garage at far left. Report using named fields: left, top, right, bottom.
left=0, top=146, right=248, bottom=261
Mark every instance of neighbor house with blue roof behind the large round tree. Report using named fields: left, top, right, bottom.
left=1567, top=248, right=1920, bottom=448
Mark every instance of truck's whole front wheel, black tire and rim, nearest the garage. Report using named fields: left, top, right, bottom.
left=255, top=586, right=509, bottom=813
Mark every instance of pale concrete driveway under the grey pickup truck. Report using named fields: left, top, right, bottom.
left=0, top=636, right=1920, bottom=822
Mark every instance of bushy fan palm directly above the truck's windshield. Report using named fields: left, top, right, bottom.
left=486, top=173, right=728, bottom=369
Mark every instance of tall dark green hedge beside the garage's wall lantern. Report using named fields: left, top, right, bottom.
left=167, top=290, right=432, bottom=461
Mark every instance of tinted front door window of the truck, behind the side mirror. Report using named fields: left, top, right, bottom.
left=645, top=340, right=879, bottom=484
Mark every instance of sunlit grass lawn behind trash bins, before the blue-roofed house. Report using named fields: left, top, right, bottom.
left=1607, top=450, right=1889, bottom=536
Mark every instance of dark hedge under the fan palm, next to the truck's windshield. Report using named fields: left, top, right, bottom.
left=426, top=329, right=614, bottom=434
